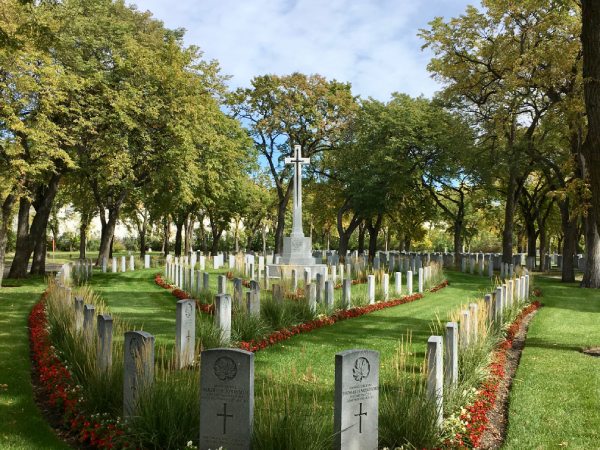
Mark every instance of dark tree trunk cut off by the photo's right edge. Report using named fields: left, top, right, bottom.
left=581, top=0, right=600, bottom=288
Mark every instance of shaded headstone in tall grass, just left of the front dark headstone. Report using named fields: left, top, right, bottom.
left=123, top=331, right=154, bottom=418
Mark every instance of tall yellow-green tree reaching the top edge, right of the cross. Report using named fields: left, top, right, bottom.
left=421, top=0, right=579, bottom=263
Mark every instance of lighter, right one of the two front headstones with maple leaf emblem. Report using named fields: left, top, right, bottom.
left=333, top=350, right=379, bottom=450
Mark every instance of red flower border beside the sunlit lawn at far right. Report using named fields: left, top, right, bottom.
left=454, top=301, right=542, bottom=448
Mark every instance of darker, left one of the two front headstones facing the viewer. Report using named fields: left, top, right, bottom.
left=198, top=348, right=254, bottom=450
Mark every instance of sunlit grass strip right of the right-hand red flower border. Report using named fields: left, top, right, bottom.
left=504, top=277, right=600, bottom=449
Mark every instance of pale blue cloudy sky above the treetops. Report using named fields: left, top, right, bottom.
left=129, top=0, right=478, bottom=100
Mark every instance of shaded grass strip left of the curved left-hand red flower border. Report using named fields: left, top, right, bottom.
left=0, top=278, right=69, bottom=450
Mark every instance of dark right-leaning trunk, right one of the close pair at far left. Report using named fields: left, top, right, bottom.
left=29, top=173, right=62, bottom=275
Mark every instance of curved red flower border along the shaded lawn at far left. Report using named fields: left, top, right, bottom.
left=28, top=291, right=129, bottom=449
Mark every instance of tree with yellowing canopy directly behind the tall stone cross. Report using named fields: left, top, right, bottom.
left=229, top=73, right=356, bottom=253
